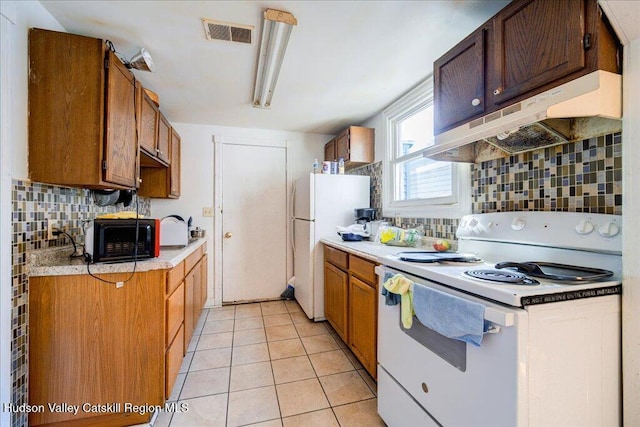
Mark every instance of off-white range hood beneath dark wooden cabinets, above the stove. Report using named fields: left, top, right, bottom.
left=424, top=70, right=622, bottom=163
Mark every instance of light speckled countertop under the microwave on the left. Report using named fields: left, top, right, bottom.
left=27, top=237, right=207, bottom=276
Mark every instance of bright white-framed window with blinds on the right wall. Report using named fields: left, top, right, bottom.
left=383, top=79, right=471, bottom=217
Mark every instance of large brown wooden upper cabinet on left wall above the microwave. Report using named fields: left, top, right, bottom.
left=29, top=29, right=139, bottom=189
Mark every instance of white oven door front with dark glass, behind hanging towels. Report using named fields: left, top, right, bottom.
left=377, top=267, right=528, bottom=427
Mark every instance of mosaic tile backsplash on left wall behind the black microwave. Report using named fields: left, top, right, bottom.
left=11, top=180, right=151, bottom=427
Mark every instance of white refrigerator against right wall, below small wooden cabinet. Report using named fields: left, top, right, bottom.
left=292, top=173, right=370, bottom=321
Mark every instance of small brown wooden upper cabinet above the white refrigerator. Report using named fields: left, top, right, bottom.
left=324, top=126, right=375, bottom=170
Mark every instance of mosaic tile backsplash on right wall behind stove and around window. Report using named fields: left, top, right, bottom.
left=349, top=132, right=622, bottom=240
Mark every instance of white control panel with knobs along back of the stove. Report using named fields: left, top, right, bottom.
left=456, top=211, right=622, bottom=252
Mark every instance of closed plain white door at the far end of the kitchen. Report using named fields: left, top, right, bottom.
left=221, top=144, right=287, bottom=302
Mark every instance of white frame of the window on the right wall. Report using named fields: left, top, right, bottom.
left=382, top=76, right=471, bottom=218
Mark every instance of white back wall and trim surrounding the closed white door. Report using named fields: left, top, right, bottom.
left=151, top=123, right=332, bottom=306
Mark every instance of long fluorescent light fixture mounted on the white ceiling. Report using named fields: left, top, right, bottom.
left=253, top=9, right=298, bottom=108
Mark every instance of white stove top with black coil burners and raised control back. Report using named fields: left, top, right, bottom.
left=378, top=212, right=622, bottom=307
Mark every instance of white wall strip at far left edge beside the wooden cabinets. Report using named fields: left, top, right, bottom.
left=0, top=1, right=64, bottom=426
